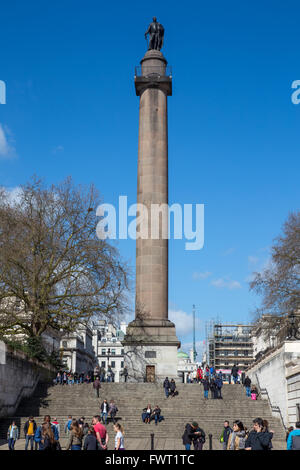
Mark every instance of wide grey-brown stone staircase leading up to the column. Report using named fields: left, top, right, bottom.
left=0, top=383, right=286, bottom=450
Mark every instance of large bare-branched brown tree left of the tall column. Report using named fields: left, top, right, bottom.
left=0, top=178, right=128, bottom=336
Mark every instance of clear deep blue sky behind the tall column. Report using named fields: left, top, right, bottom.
left=0, top=0, right=300, bottom=358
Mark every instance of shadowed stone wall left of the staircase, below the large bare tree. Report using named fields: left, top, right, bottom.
left=0, top=341, right=55, bottom=417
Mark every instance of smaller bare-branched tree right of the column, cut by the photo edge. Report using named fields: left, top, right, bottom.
left=250, top=212, right=300, bottom=328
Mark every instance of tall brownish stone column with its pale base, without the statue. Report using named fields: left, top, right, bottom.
left=123, top=50, right=180, bottom=381
